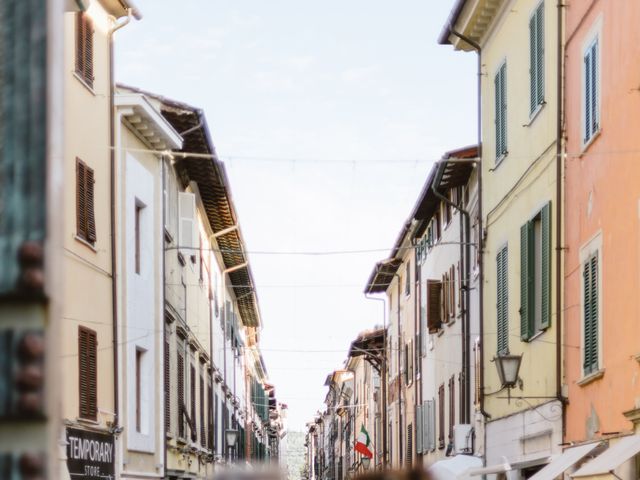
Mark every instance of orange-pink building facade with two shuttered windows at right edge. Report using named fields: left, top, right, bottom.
left=564, top=0, right=640, bottom=442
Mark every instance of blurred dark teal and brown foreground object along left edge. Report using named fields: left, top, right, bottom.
left=0, top=0, right=62, bottom=480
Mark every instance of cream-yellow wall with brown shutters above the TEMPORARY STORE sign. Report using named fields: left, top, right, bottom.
left=60, top=2, right=114, bottom=427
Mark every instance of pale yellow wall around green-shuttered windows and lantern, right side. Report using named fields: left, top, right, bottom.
left=481, top=0, right=557, bottom=420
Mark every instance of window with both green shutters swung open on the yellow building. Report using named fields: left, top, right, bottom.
left=520, top=203, right=551, bottom=341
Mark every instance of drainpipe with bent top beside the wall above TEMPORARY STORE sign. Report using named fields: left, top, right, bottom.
left=107, top=8, right=133, bottom=458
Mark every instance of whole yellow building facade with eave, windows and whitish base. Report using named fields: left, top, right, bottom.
left=441, top=0, right=563, bottom=472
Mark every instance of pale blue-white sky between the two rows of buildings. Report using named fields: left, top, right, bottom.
left=116, top=0, right=476, bottom=430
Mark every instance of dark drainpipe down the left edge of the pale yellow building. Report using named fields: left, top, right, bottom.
left=449, top=24, right=491, bottom=424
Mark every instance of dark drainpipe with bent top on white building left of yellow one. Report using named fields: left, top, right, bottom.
left=431, top=178, right=471, bottom=423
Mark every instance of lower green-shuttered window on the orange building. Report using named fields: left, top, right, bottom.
left=582, top=253, right=599, bottom=375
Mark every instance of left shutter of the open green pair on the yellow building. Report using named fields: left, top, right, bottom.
left=520, top=221, right=535, bottom=341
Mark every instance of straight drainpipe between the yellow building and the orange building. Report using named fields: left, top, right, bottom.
left=556, top=0, right=567, bottom=443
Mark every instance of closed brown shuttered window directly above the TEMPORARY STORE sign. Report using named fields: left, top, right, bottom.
left=78, top=327, right=98, bottom=420
